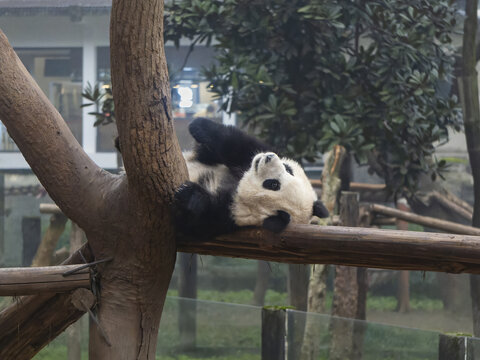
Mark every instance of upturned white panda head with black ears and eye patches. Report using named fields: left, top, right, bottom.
left=232, top=152, right=328, bottom=231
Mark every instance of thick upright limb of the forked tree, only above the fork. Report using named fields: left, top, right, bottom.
left=110, top=0, right=187, bottom=206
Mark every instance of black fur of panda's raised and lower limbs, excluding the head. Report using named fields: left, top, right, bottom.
left=175, top=118, right=269, bottom=239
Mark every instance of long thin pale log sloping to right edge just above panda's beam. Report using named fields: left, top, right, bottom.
left=370, top=204, right=480, bottom=235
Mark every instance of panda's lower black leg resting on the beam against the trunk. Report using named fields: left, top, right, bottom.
left=175, top=181, right=238, bottom=239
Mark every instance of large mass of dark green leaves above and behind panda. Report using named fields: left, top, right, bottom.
left=165, top=0, right=460, bottom=192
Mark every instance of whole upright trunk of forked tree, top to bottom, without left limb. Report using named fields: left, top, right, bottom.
left=87, top=0, right=187, bottom=360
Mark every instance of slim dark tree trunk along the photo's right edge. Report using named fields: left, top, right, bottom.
left=459, top=0, right=480, bottom=336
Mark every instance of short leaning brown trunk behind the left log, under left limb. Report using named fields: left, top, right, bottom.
left=32, top=214, right=68, bottom=266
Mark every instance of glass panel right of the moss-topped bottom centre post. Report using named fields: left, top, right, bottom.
left=287, top=310, right=439, bottom=360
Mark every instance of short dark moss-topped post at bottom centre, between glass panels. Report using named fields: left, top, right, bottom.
left=262, top=307, right=287, bottom=360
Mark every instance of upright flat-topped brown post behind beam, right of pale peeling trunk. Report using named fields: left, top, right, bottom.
left=329, top=192, right=359, bottom=360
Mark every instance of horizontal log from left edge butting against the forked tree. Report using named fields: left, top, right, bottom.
left=0, top=265, right=90, bottom=296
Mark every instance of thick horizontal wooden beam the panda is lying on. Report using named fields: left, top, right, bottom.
left=177, top=225, right=480, bottom=274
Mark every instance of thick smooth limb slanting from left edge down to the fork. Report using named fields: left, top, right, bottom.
left=0, top=30, right=121, bottom=228
